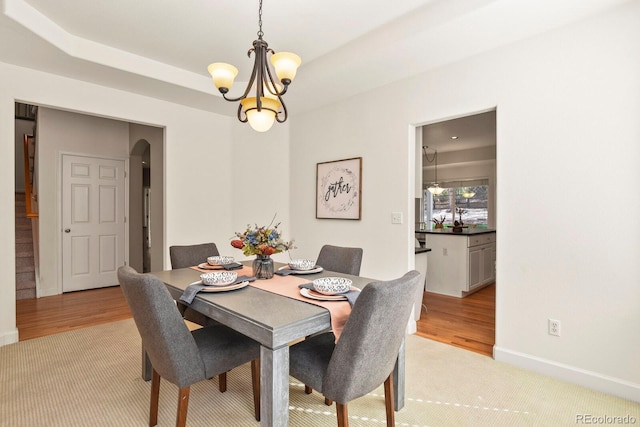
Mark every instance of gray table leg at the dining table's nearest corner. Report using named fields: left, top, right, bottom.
left=260, top=345, right=289, bottom=427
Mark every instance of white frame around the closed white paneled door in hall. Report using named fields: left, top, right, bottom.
left=56, top=151, right=129, bottom=294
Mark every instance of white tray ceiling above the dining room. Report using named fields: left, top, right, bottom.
left=0, top=0, right=625, bottom=116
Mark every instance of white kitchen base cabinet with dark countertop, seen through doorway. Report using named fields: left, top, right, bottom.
left=424, top=230, right=496, bottom=297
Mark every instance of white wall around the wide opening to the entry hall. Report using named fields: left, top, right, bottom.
left=0, top=63, right=272, bottom=345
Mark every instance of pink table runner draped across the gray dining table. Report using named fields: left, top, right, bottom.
left=191, top=266, right=351, bottom=341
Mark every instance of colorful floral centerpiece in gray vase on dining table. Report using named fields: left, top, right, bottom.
left=231, top=216, right=295, bottom=279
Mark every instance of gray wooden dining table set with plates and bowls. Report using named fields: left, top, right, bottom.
left=147, top=261, right=405, bottom=426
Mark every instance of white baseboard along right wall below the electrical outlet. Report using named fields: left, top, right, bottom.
left=493, top=346, right=640, bottom=402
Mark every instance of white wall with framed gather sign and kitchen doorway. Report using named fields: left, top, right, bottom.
left=291, top=1, right=640, bottom=401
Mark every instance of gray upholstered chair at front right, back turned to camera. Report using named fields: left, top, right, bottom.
left=289, top=270, right=422, bottom=427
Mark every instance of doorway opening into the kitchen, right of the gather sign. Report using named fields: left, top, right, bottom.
left=415, top=108, right=497, bottom=356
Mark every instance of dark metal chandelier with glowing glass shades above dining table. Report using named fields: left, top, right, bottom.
left=207, top=0, right=301, bottom=132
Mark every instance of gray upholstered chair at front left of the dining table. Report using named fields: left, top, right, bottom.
left=118, top=266, right=260, bottom=426
